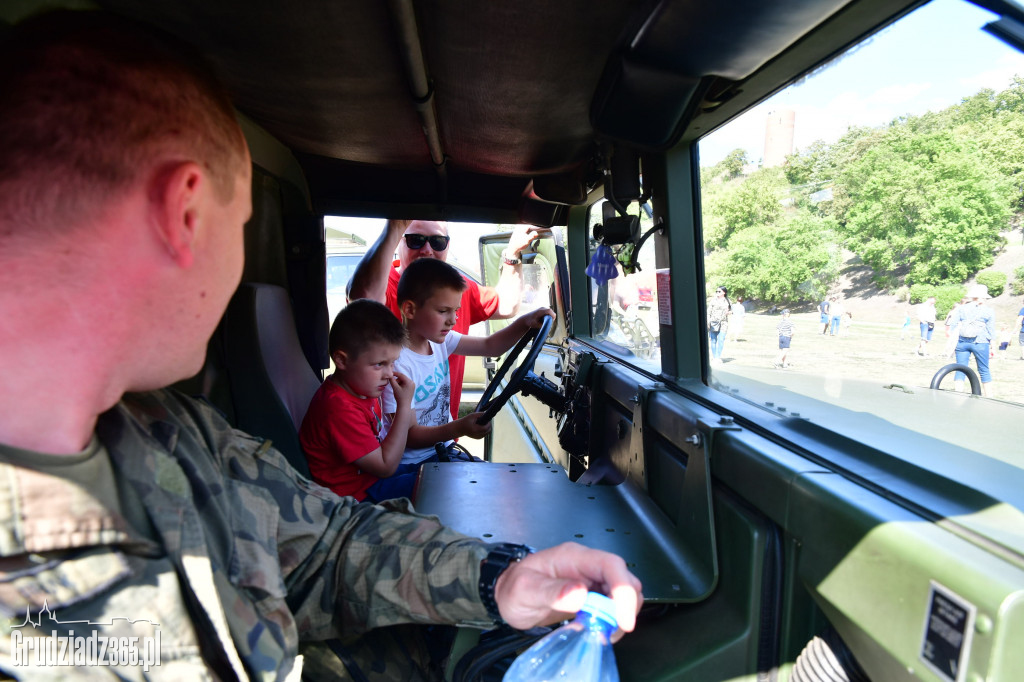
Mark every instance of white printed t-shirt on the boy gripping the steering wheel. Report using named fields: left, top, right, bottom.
left=383, top=332, right=462, bottom=464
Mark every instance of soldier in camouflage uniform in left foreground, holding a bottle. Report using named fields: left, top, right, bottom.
left=0, top=6, right=642, bottom=680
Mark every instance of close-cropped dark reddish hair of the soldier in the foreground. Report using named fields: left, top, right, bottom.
left=0, top=10, right=246, bottom=236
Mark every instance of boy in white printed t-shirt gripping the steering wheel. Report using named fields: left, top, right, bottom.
left=383, top=258, right=554, bottom=466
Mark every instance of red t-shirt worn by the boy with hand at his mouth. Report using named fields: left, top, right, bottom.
left=299, top=379, right=381, bottom=500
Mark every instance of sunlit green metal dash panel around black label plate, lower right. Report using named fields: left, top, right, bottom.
left=787, top=474, right=1024, bottom=680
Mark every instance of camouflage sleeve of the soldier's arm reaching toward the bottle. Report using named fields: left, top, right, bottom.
left=173, top=393, right=493, bottom=640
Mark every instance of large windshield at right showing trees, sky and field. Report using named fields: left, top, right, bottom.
left=698, top=0, right=1024, bottom=462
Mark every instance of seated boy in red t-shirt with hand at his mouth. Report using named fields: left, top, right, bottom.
left=299, top=299, right=419, bottom=502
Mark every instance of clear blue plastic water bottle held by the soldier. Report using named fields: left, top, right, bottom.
left=502, top=592, right=618, bottom=682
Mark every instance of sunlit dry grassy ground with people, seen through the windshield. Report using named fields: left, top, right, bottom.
left=722, top=313, right=1024, bottom=404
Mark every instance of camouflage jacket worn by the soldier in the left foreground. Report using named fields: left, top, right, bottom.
left=0, top=391, right=489, bottom=680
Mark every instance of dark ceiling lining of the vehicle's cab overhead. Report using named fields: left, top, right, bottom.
left=97, top=0, right=913, bottom=218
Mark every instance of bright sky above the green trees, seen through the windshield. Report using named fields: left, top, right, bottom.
left=699, top=0, right=1024, bottom=166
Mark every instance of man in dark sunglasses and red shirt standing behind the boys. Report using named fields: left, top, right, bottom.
left=348, top=220, right=542, bottom=419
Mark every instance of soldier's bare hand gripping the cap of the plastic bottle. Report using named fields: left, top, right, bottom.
left=495, top=543, right=643, bottom=641
